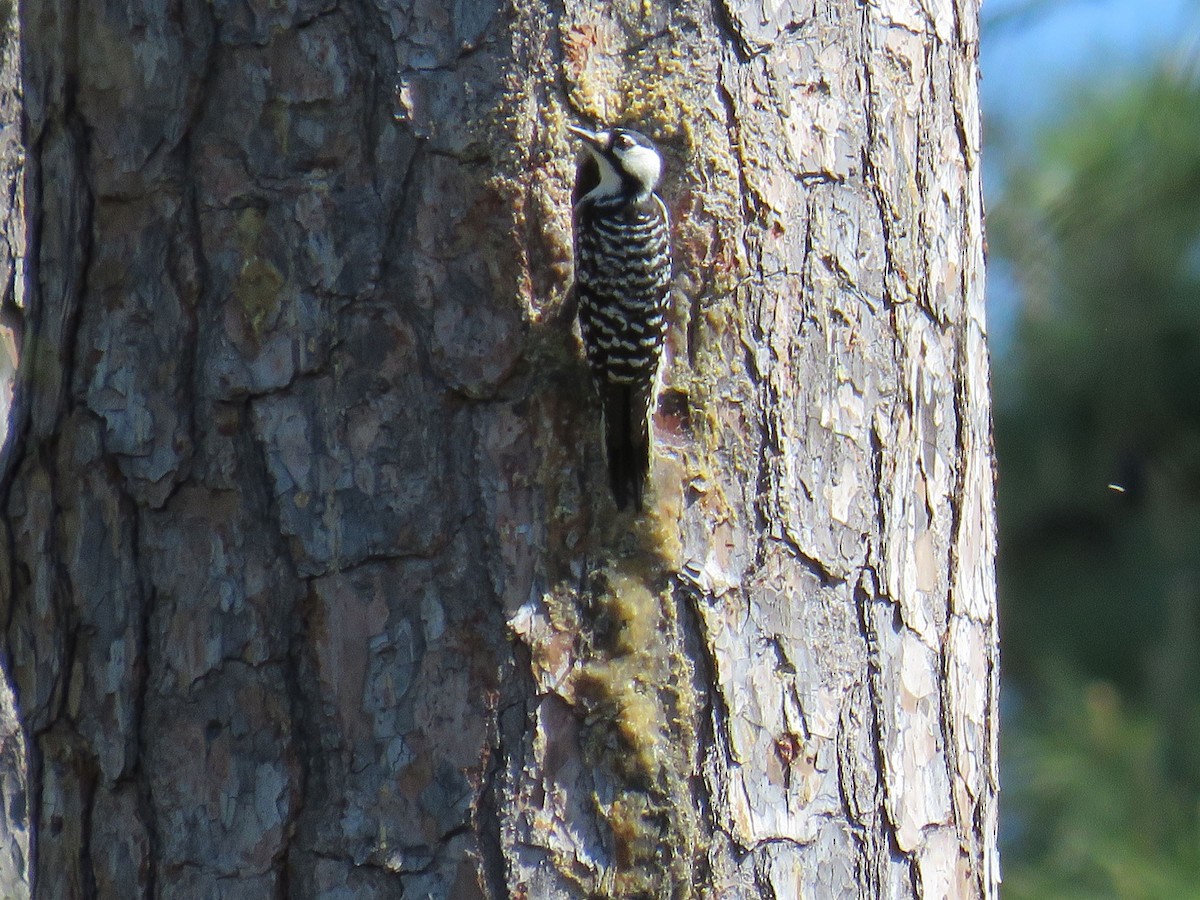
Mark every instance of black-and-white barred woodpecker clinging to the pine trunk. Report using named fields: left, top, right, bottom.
left=568, top=126, right=671, bottom=510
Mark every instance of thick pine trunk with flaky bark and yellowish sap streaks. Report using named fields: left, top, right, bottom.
left=0, top=0, right=998, bottom=899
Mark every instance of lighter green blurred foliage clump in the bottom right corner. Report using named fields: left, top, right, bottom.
left=1003, top=673, right=1200, bottom=900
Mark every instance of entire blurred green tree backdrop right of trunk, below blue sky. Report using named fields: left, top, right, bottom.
left=984, top=4, right=1200, bottom=900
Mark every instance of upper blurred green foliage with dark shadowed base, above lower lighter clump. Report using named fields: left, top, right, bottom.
left=989, top=78, right=1200, bottom=700
